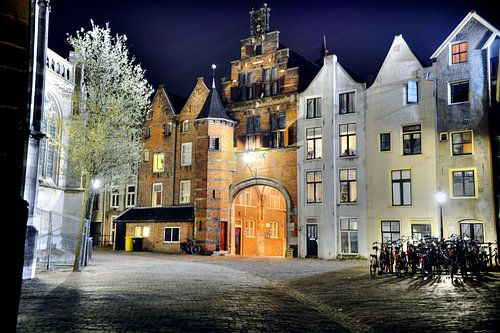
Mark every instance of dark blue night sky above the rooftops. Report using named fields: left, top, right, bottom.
left=49, top=0, right=500, bottom=97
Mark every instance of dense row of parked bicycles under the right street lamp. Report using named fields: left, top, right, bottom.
left=370, top=235, right=499, bottom=280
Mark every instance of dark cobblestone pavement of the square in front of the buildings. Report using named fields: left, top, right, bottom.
left=18, top=251, right=500, bottom=332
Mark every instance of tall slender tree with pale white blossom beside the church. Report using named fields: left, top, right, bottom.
left=68, top=21, right=153, bottom=271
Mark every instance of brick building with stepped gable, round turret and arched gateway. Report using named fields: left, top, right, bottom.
left=117, top=5, right=318, bottom=256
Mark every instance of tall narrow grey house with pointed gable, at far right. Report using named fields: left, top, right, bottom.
left=431, top=12, right=500, bottom=242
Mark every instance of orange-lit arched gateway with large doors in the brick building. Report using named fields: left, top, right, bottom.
left=229, top=178, right=291, bottom=256
